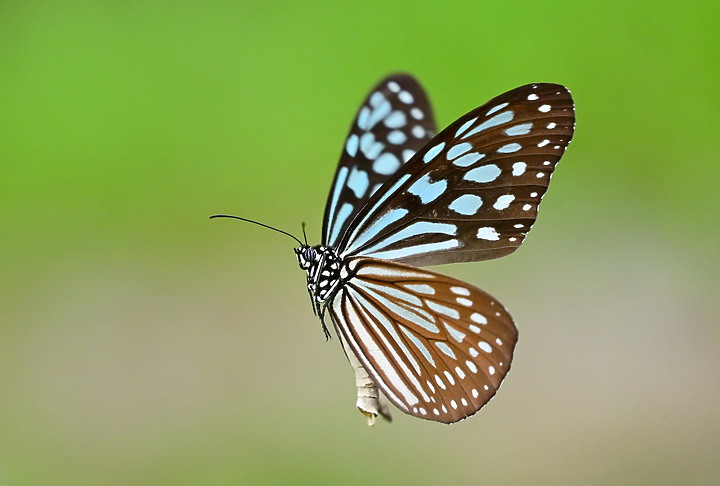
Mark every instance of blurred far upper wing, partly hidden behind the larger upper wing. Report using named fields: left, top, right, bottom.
left=323, top=74, right=436, bottom=246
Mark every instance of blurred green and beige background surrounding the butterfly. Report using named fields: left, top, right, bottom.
left=0, top=0, right=720, bottom=485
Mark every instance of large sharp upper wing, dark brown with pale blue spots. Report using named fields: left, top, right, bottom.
left=339, top=83, right=575, bottom=266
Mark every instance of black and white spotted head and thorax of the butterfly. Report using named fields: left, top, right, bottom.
left=295, top=245, right=348, bottom=304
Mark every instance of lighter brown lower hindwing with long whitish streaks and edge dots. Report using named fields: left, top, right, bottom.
left=330, top=258, right=517, bottom=423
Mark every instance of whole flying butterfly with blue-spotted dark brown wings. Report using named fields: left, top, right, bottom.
left=214, top=74, right=575, bottom=425
